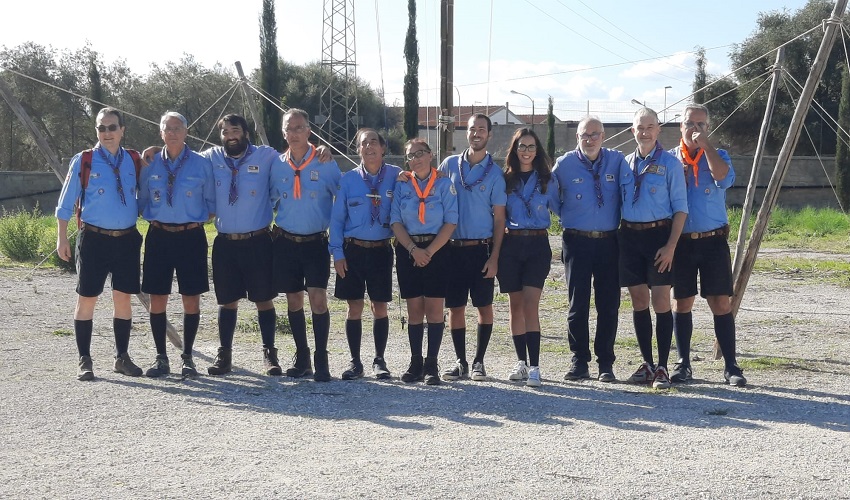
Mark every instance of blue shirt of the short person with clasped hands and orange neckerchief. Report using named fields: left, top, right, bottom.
left=390, top=173, right=457, bottom=236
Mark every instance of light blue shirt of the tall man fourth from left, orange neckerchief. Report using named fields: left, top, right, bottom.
left=272, top=146, right=342, bottom=235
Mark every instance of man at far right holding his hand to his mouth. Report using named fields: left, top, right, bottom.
left=670, top=104, right=747, bottom=387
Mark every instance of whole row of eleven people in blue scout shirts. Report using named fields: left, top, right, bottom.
left=56, top=104, right=746, bottom=389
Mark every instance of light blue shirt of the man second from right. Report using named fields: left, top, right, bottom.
left=620, top=143, right=688, bottom=222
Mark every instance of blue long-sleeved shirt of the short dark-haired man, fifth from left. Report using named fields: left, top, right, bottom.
left=328, top=163, right=401, bottom=260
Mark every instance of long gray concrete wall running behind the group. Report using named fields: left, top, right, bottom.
left=0, top=154, right=838, bottom=214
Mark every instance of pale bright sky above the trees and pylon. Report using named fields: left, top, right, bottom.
left=0, top=0, right=806, bottom=121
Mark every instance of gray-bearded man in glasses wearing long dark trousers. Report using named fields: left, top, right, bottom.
left=552, top=116, right=628, bottom=382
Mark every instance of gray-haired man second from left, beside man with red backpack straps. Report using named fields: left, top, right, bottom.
left=139, top=111, right=215, bottom=377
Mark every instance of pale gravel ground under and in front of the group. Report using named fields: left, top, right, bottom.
left=0, top=248, right=850, bottom=498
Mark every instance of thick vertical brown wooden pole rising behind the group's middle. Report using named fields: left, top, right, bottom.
left=437, top=0, right=455, bottom=162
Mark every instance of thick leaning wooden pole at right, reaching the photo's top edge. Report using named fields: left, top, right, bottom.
left=732, top=0, right=847, bottom=314
